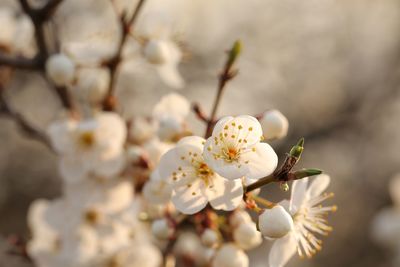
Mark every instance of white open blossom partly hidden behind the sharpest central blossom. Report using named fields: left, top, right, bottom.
left=159, top=136, right=243, bottom=214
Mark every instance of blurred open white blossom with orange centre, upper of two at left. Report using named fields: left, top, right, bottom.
left=48, top=112, right=126, bottom=182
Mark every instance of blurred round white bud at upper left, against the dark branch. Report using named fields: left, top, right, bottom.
left=46, top=54, right=75, bottom=86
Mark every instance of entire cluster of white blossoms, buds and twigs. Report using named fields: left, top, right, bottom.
left=0, top=1, right=336, bottom=267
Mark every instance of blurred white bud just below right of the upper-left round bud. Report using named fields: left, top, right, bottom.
left=76, top=68, right=110, bottom=103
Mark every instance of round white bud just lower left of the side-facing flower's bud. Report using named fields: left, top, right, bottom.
left=233, top=222, right=262, bottom=250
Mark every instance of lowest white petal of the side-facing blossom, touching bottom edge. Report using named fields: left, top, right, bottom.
left=268, top=234, right=297, bottom=267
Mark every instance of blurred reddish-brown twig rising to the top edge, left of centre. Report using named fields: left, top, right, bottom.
left=103, top=0, right=145, bottom=111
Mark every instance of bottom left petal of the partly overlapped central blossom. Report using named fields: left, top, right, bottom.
left=172, top=180, right=208, bottom=214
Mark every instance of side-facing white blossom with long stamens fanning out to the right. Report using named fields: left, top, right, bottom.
left=269, top=174, right=336, bottom=267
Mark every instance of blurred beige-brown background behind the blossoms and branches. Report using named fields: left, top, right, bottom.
left=0, top=0, right=400, bottom=267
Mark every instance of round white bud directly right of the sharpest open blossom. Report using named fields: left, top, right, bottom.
left=260, top=109, right=289, bottom=139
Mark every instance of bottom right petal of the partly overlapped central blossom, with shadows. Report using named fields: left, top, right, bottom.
left=206, top=175, right=243, bottom=213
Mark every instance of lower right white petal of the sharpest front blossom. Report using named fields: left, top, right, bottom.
left=240, top=143, right=278, bottom=179
